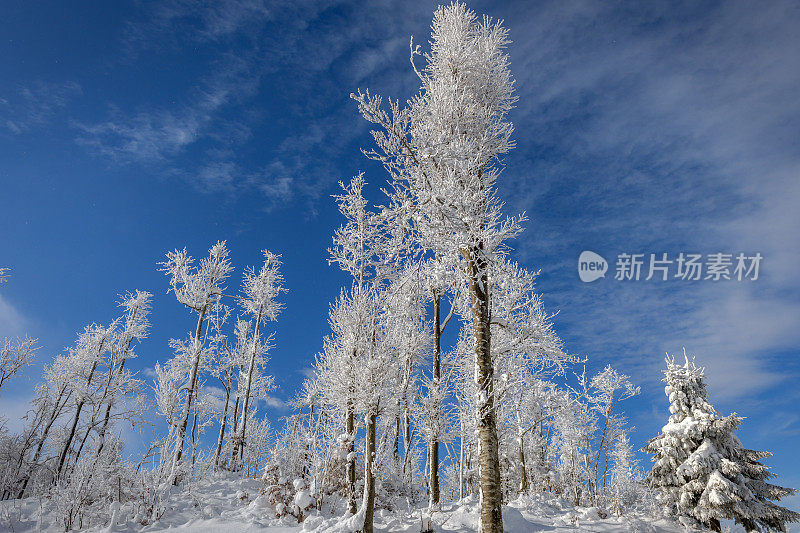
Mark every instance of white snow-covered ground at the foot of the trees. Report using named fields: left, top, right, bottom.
left=0, top=479, right=683, bottom=533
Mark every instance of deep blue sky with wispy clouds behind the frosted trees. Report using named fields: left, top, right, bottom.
left=0, top=0, right=800, bottom=508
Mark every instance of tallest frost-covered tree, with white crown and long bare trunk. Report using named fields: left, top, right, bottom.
left=353, top=3, right=520, bottom=533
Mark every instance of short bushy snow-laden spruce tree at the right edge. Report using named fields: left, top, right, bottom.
left=644, top=351, right=800, bottom=531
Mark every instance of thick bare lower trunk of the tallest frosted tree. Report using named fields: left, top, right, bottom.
left=464, top=246, right=503, bottom=533
